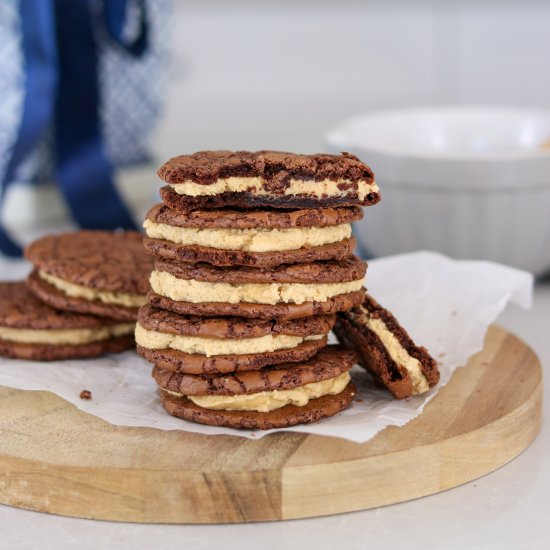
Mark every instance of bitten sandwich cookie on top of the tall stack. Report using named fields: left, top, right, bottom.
left=158, top=151, right=380, bottom=212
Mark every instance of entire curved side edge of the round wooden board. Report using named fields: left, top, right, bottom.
left=0, top=382, right=542, bottom=524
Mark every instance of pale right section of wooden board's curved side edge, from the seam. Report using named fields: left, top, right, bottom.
left=282, top=378, right=543, bottom=519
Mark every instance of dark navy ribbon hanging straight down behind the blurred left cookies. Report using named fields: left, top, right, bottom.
left=55, top=0, right=135, bottom=233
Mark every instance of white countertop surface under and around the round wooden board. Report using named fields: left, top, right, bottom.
left=0, top=260, right=550, bottom=550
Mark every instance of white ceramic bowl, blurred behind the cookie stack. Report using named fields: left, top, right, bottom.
left=326, top=107, right=550, bottom=275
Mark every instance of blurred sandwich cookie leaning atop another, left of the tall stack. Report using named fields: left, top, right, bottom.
left=25, top=231, right=153, bottom=320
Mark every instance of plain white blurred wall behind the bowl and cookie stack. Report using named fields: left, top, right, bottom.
left=153, top=0, right=550, bottom=155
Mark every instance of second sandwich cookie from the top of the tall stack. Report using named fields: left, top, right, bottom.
left=144, top=204, right=363, bottom=268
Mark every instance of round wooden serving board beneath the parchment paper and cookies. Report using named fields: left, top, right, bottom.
left=0, top=327, right=542, bottom=523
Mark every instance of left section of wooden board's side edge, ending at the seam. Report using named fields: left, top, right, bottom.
left=0, top=462, right=288, bottom=524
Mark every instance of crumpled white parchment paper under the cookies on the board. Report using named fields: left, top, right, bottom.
left=0, top=252, right=533, bottom=442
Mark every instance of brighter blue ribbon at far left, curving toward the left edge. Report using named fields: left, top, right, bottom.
left=0, top=0, right=57, bottom=256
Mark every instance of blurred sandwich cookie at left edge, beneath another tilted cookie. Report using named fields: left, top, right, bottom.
left=0, top=282, right=134, bottom=361
